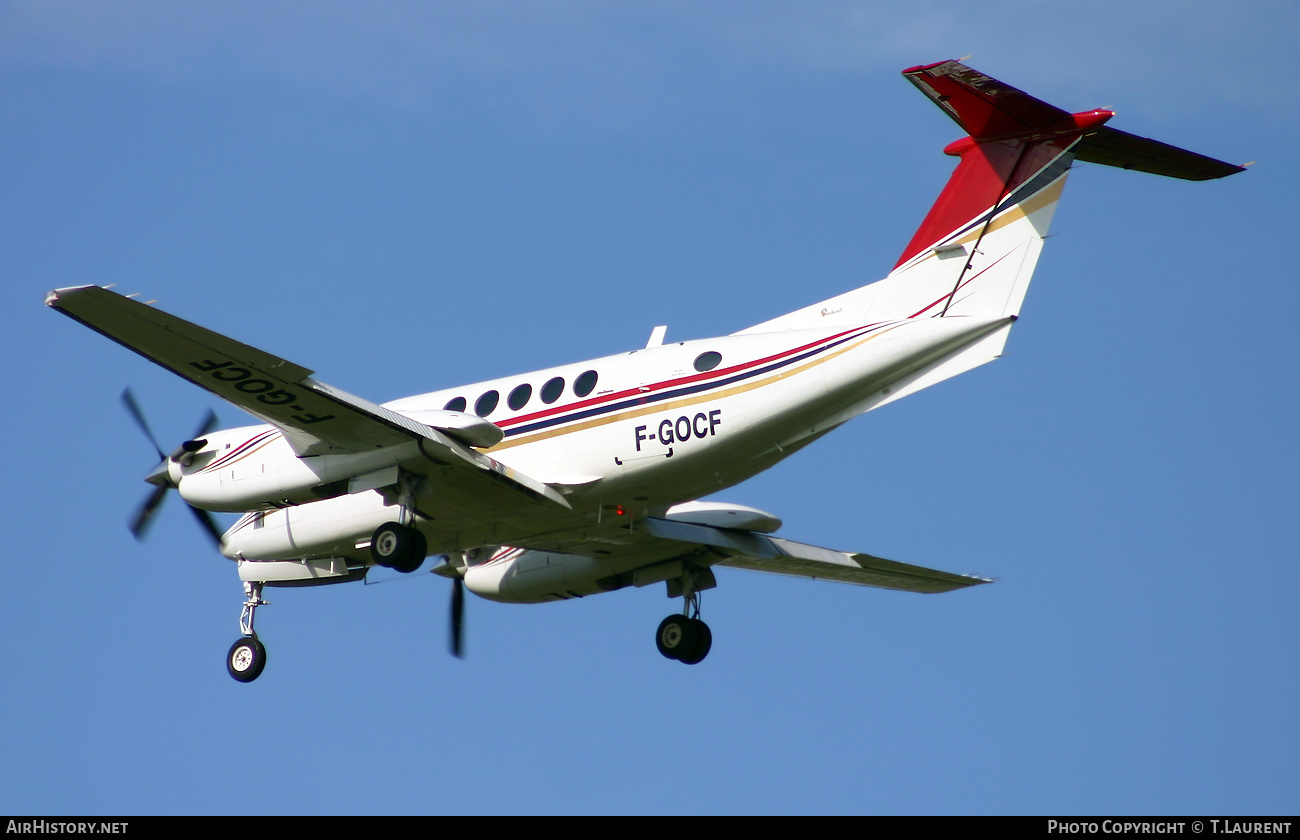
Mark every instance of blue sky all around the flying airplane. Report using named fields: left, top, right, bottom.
left=0, top=1, right=1300, bottom=815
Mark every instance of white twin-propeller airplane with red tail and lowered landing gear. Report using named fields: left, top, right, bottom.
left=46, top=61, right=1243, bottom=683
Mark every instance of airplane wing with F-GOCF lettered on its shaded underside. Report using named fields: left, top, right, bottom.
left=46, top=286, right=569, bottom=508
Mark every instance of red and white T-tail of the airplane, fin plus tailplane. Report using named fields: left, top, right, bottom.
left=744, top=61, right=1242, bottom=338
